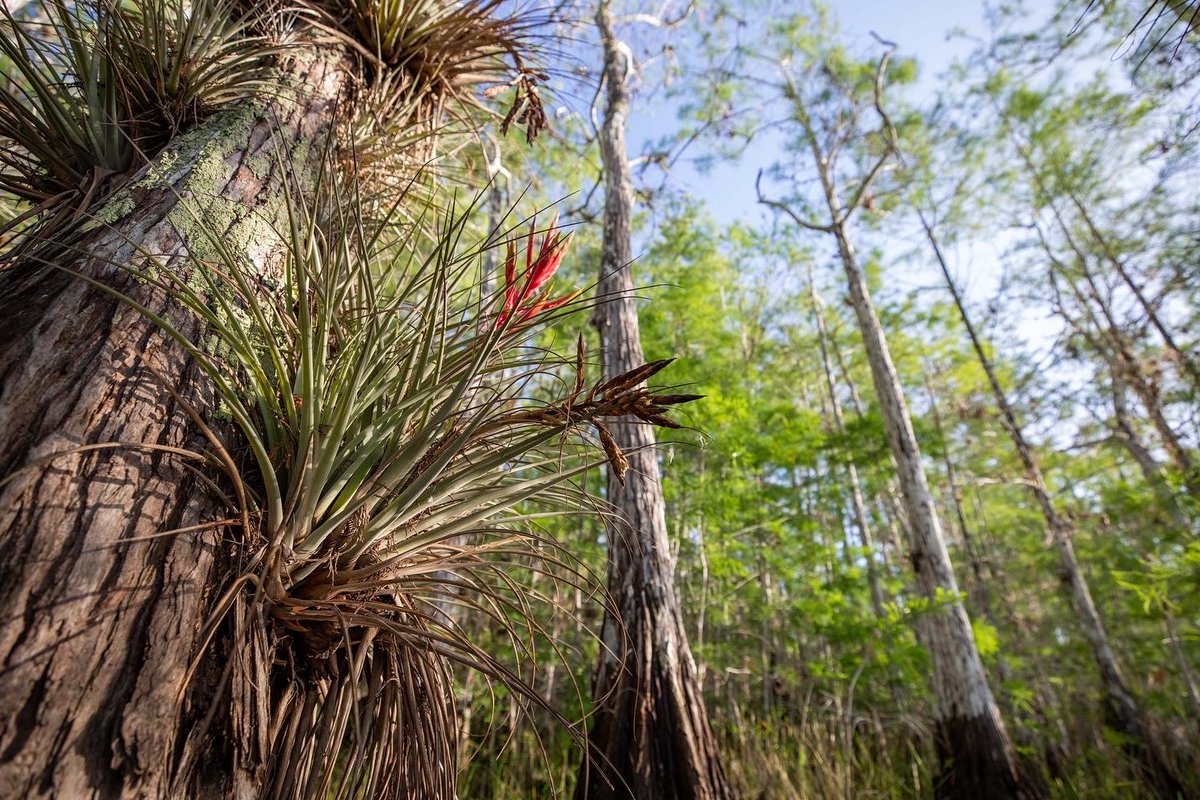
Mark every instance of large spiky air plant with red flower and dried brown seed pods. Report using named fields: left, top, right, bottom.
left=70, top=160, right=695, bottom=798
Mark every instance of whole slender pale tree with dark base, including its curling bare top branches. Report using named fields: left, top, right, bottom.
left=758, top=38, right=1040, bottom=799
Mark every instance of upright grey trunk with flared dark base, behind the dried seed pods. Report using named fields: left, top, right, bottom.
left=576, top=6, right=731, bottom=800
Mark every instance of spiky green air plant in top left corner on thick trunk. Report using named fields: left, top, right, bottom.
left=0, top=0, right=275, bottom=247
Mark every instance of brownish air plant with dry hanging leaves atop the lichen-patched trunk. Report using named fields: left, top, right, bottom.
left=316, top=0, right=546, bottom=193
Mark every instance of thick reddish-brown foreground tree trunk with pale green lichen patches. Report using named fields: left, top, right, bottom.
left=0, top=48, right=344, bottom=799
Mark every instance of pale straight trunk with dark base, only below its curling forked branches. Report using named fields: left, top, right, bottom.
left=827, top=225, right=1040, bottom=800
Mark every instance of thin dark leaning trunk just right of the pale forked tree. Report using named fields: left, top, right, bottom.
left=918, top=211, right=1182, bottom=799
